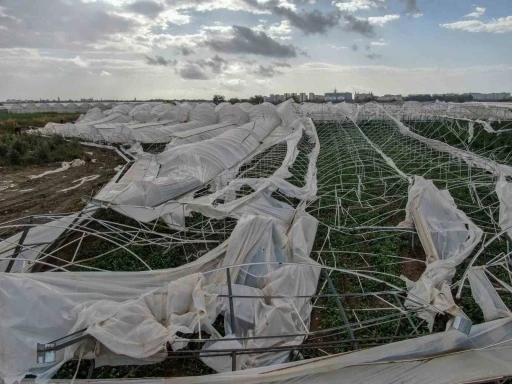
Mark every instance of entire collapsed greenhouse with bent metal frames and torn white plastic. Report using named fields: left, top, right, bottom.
left=0, top=100, right=512, bottom=383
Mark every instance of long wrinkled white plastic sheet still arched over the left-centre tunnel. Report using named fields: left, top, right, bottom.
left=97, top=103, right=300, bottom=207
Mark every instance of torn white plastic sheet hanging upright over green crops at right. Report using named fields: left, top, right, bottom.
left=402, top=176, right=483, bottom=330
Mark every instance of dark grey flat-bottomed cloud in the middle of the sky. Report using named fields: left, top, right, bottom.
left=204, top=25, right=297, bottom=58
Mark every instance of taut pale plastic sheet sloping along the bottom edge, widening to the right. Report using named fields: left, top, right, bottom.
left=22, top=318, right=512, bottom=384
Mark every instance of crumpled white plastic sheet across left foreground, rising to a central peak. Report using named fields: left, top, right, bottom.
left=0, top=212, right=319, bottom=383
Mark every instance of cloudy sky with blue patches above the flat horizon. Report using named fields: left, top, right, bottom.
left=0, top=0, right=512, bottom=100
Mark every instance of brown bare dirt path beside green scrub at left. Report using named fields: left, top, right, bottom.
left=0, top=148, right=125, bottom=222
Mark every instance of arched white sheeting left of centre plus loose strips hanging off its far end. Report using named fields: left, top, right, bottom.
left=95, top=103, right=312, bottom=218
